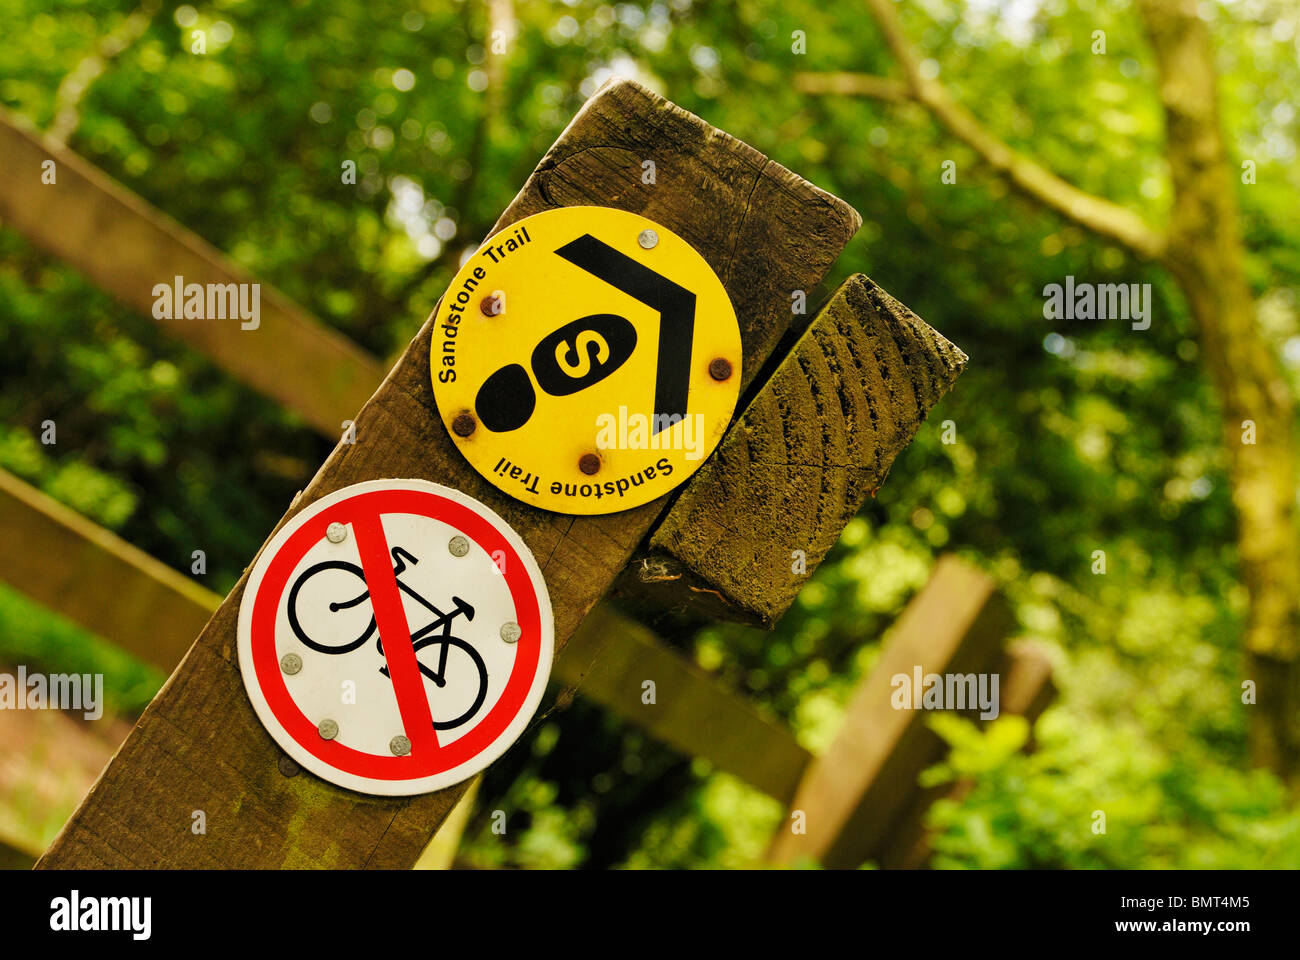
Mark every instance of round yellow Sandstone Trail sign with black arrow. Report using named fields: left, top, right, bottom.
left=429, top=207, right=741, bottom=514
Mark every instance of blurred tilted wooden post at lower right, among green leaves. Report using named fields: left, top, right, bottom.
left=768, top=557, right=1013, bottom=868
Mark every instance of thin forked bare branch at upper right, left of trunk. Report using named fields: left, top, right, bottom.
left=796, top=0, right=1166, bottom=260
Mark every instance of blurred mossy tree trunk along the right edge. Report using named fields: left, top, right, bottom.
left=1141, top=0, right=1300, bottom=787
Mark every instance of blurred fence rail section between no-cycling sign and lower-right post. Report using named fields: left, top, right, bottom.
left=555, top=604, right=811, bottom=803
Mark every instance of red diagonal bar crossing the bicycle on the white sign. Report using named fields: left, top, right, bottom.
left=352, top=514, right=438, bottom=756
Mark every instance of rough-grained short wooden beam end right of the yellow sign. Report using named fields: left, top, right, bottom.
left=619, top=273, right=966, bottom=626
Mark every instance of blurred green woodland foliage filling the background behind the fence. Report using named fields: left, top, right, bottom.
left=0, top=0, right=1300, bottom=868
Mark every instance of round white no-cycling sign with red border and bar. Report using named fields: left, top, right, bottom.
left=239, top=480, right=554, bottom=795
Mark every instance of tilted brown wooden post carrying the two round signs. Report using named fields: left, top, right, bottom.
left=39, top=81, right=859, bottom=868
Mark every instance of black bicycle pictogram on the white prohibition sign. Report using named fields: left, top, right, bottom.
left=287, top=546, right=488, bottom=730
